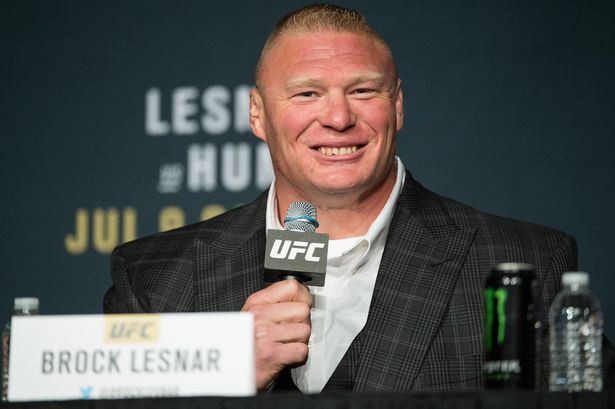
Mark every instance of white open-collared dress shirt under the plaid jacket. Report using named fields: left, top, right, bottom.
left=266, top=157, right=406, bottom=393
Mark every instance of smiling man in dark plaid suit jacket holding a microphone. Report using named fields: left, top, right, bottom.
left=104, top=5, right=612, bottom=392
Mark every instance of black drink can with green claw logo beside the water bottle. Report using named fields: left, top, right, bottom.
left=483, top=263, right=541, bottom=389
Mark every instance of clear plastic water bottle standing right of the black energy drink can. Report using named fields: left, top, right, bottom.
left=549, top=272, right=602, bottom=392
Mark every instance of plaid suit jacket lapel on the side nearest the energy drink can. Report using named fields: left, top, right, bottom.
left=354, top=173, right=475, bottom=391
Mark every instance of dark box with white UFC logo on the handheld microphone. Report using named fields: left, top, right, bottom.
left=265, top=230, right=329, bottom=286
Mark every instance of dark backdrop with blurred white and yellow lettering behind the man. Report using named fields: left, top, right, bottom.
left=0, top=0, right=615, bottom=336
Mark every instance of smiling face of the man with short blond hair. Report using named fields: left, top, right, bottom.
left=250, top=32, right=403, bottom=200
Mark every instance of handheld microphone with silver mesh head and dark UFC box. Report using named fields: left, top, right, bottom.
left=265, top=202, right=329, bottom=287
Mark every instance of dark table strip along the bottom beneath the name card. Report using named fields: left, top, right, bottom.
left=0, top=390, right=615, bottom=409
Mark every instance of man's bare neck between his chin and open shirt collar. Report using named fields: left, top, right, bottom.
left=276, top=167, right=397, bottom=240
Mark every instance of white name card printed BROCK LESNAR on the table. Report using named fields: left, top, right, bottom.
left=8, top=312, right=256, bottom=401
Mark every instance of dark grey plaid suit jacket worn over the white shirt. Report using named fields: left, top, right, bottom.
left=104, top=173, right=615, bottom=391
